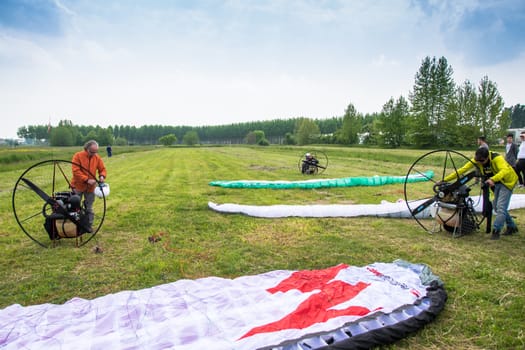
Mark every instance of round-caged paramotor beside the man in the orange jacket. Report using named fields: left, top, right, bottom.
left=12, top=160, right=106, bottom=248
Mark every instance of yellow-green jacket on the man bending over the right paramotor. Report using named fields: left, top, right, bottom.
left=443, top=151, right=518, bottom=190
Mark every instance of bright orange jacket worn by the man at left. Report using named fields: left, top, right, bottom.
left=71, top=150, right=106, bottom=192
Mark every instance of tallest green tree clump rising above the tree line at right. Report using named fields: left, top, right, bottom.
left=408, top=56, right=455, bottom=147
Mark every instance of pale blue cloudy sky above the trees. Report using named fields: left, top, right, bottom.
left=0, top=0, right=525, bottom=138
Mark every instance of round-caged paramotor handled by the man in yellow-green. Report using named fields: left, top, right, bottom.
left=404, top=150, right=492, bottom=237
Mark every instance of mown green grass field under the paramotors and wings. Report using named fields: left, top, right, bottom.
left=0, top=146, right=525, bottom=349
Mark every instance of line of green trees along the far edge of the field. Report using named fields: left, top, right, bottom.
left=17, top=56, right=525, bottom=148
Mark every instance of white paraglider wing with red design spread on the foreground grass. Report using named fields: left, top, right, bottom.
left=0, top=261, right=447, bottom=350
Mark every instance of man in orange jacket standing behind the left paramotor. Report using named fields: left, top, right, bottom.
left=71, top=140, right=106, bottom=232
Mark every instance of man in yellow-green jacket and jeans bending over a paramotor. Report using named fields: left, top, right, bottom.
left=443, top=147, right=518, bottom=239
